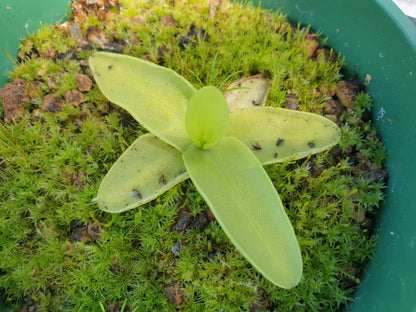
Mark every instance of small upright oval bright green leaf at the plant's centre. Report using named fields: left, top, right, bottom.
left=185, top=86, right=229, bottom=149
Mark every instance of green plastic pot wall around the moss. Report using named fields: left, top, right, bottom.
left=0, top=0, right=416, bottom=312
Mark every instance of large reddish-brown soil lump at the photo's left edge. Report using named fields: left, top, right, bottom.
left=0, top=78, right=29, bottom=123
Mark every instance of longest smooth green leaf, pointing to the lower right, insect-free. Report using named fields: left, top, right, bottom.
left=183, top=138, right=302, bottom=288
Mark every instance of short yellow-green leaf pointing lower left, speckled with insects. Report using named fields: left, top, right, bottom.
left=97, top=134, right=188, bottom=212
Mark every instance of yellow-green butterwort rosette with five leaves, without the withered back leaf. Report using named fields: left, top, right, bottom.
left=89, top=52, right=340, bottom=288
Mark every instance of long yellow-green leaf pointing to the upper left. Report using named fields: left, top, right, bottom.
left=89, top=52, right=196, bottom=151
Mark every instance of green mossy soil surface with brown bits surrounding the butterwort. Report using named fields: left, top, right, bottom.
left=0, top=0, right=387, bottom=311
